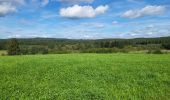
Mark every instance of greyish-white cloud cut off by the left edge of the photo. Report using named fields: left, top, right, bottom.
left=0, top=3, right=17, bottom=16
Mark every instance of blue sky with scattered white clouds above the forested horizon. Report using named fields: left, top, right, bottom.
left=0, top=0, right=170, bottom=39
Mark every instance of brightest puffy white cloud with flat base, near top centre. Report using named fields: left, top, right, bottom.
left=60, top=5, right=109, bottom=18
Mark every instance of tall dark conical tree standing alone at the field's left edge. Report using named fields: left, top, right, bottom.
left=8, top=38, right=21, bottom=55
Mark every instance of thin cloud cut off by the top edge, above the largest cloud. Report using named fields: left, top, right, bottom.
left=57, top=0, right=94, bottom=4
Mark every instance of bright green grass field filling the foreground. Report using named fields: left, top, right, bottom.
left=0, top=54, right=170, bottom=100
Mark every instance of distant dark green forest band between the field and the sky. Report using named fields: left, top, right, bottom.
left=0, top=37, right=170, bottom=55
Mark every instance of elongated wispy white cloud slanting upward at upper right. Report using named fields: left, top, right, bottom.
left=122, top=5, right=166, bottom=18
